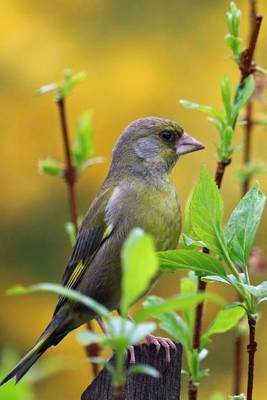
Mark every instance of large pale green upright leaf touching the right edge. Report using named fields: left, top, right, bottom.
left=225, top=184, right=265, bottom=269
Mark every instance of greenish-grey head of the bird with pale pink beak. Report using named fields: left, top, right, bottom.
left=112, top=117, right=204, bottom=175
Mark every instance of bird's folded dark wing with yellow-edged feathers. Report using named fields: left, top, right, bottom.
left=54, top=187, right=115, bottom=314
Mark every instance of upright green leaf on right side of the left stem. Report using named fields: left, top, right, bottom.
left=72, top=112, right=93, bottom=170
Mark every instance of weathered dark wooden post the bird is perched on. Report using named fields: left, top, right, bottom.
left=81, top=343, right=182, bottom=400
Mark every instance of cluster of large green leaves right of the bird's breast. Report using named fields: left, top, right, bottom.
left=159, top=169, right=267, bottom=318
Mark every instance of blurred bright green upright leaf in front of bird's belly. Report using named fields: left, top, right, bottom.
left=121, top=228, right=158, bottom=316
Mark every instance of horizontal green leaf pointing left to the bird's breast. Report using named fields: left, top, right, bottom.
left=158, top=250, right=226, bottom=277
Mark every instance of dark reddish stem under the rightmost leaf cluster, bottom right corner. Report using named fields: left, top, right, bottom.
left=247, top=317, right=257, bottom=400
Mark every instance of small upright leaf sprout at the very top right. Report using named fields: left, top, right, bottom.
left=225, top=1, right=241, bottom=64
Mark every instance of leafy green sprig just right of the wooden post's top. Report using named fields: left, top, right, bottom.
left=144, top=274, right=241, bottom=385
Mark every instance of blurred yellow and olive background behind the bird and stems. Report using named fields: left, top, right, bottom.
left=0, top=0, right=267, bottom=400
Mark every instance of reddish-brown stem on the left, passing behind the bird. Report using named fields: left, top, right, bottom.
left=56, top=96, right=100, bottom=377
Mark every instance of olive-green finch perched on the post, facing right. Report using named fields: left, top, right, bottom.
left=0, top=117, right=204, bottom=385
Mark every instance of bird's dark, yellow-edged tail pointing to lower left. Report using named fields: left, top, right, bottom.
left=0, top=320, right=67, bottom=386
